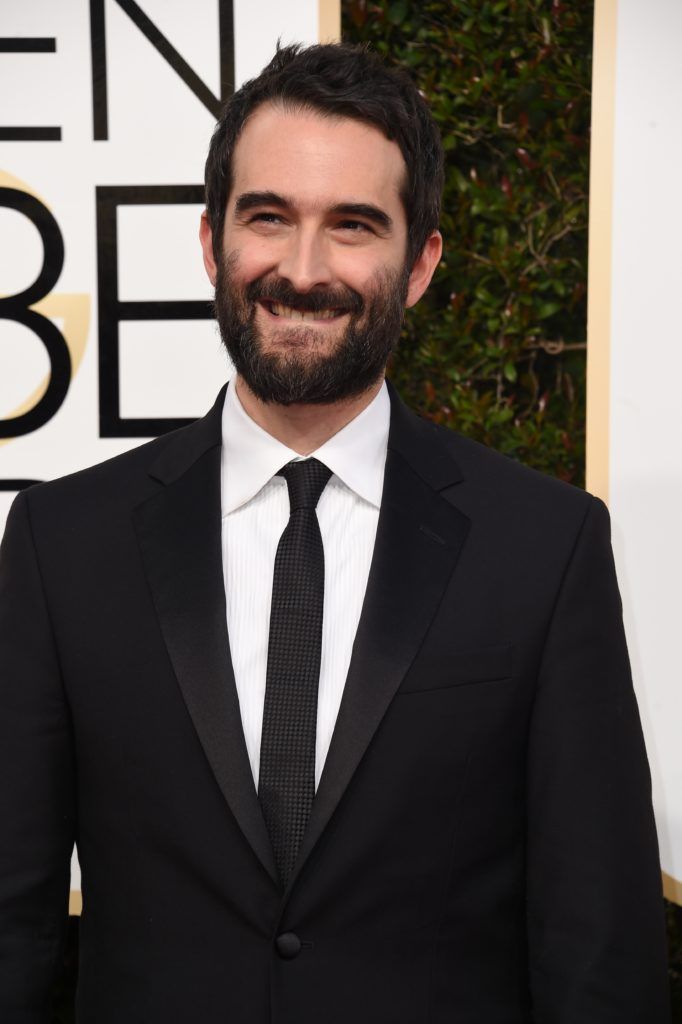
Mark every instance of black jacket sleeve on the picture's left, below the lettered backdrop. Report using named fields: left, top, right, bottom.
left=0, top=494, right=76, bottom=1024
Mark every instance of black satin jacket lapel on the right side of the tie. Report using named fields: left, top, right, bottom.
left=291, top=400, right=469, bottom=884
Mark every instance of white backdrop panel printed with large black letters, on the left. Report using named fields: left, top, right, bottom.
left=0, top=0, right=327, bottom=901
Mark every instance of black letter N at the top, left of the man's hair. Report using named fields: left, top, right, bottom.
left=90, top=0, right=235, bottom=141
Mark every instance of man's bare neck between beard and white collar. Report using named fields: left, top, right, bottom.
left=237, top=376, right=384, bottom=455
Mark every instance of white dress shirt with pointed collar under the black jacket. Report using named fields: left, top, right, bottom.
left=221, top=381, right=390, bottom=788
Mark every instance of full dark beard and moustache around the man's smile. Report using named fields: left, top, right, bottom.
left=214, top=253, right=410, bottom=406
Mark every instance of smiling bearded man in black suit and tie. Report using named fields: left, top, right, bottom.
left=0, top=46, right=668, bottom=1024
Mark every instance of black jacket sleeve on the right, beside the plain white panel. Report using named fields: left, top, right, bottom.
left=527, top=499, right=670, bottom=1024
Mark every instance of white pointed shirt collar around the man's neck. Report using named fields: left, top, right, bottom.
left=222, top=380, right=390, bottom=516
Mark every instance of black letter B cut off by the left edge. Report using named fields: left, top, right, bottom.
left=0, top=188, right=71, bottom=437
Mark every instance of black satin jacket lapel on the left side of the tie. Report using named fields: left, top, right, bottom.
left=134, top=428, right=278, bottom=881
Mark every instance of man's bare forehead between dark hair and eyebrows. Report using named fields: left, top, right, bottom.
left=231, top=103, right=407, bottom=212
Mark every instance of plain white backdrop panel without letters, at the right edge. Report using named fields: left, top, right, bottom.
left=604, top=0, right=682, bottom=902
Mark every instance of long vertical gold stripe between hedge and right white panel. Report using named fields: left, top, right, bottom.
left=586, top=0, right=619, bottom=501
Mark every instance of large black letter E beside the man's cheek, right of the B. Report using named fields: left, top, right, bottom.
left=96, top=185, right=213, bottom=437
